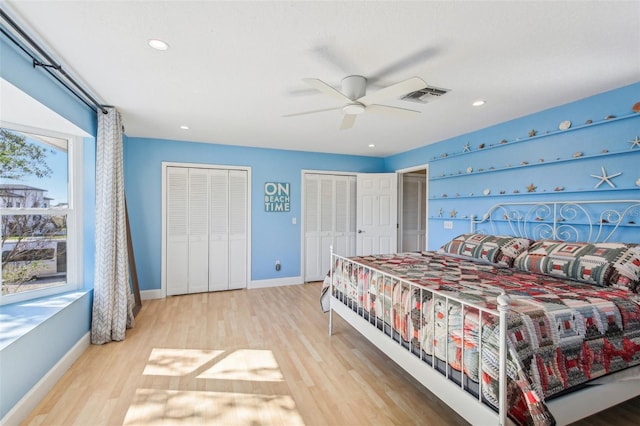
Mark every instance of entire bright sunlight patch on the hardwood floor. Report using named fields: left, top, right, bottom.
left=130, top=348, right=304, bottom=426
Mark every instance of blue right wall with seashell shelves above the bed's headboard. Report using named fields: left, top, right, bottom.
left=385, top=83, right=640, bottom=250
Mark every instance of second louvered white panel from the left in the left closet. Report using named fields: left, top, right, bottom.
left=188, top=168, right=210, bottom=293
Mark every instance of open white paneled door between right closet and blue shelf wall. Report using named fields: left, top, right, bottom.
left=356, top=173, right=398, bottom=256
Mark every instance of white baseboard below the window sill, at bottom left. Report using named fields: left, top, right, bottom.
left=0, top=332, right=91, bottom=426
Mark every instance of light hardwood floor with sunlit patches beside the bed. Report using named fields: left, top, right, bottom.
left=24, top=283, right=640, bottom=426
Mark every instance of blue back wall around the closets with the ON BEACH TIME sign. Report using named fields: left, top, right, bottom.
left=125, top=138, right=384, bottom=290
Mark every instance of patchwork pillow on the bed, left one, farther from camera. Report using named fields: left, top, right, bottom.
left=438, top=233, right=531, bottom=266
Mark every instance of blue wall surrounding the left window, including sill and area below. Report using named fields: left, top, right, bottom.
left=0, top=39, right=97, bottom=419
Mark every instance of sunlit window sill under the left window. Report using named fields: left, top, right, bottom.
left=0, top=290, right=92, bottom=351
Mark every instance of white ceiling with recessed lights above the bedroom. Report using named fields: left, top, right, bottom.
left=3, top=0, right=640, bottom=156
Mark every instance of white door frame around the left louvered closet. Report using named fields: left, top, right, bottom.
left=160, top=161, right=252, bottom=297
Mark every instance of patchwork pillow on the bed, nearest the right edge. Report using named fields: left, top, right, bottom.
left=514, top=240, right=640, bottom=291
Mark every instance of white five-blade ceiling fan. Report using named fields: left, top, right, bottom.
left=283, top=75, right=427, bottom=130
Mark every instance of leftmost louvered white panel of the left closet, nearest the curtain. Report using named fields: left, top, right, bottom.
left=165, top=167, right=189, bottom=296
